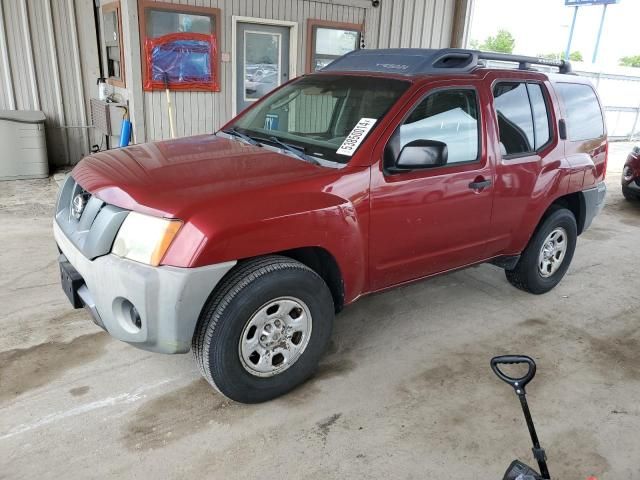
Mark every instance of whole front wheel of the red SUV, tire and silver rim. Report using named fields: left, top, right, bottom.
left=192, top=256, right=334, bottom=403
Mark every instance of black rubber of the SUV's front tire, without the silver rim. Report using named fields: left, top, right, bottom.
left=192, top=255, right=335, bottom=403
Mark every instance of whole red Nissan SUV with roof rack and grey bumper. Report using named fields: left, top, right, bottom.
left=54, top=49, right=607, bottom=402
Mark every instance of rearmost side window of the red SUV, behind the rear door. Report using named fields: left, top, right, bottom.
left=555, top=83, right=604, bottom=141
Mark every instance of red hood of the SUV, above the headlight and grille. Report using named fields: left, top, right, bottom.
left=72, top=135, right=332, bottom=219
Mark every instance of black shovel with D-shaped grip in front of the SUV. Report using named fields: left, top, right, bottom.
left=491, top=355, right=551, bottom=480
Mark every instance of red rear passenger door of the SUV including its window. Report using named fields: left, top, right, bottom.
left=487, top=71, right=566, bottom=256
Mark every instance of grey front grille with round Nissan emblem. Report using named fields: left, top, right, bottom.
left=56, top=175, right=129, bottom=260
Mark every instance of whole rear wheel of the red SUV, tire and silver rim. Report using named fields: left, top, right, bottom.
left=505, top=207, right=578, bottom=294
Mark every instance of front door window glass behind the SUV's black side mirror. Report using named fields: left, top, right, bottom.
left=398, top=89, right=479, bottom=164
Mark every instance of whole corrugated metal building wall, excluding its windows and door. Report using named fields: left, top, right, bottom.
left=0, top=0, right=460, bottom=166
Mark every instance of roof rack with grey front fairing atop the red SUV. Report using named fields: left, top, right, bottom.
left=322, top=48, right=571, bottom=75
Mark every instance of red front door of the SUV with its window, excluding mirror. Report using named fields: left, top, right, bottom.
left=370, top=80, right=493, bottom=290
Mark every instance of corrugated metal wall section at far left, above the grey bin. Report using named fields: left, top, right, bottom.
left=0, top=0, right=98, bottom=165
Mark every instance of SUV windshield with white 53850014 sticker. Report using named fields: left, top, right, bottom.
left=230, top=75, right=409, bottom=163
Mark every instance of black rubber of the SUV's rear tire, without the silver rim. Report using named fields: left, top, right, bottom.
left=505, top=206, right=578, bottom=295
